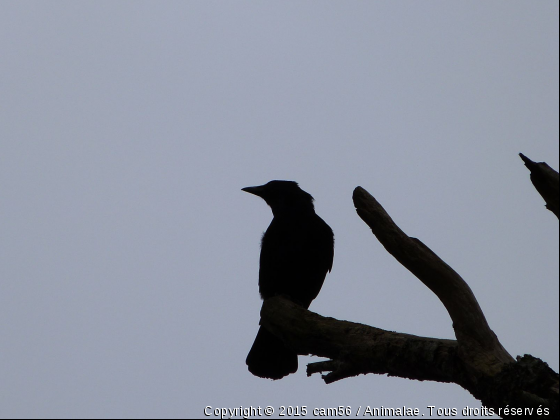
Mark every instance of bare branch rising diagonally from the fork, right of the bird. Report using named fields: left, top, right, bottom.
left=353, top=187, right=513, bottom=373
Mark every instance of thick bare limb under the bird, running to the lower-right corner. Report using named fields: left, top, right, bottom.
left=261, top=296, right=558, bottom=418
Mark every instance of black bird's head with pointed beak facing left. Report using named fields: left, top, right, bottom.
left=242, top=181, right=314, bottom=216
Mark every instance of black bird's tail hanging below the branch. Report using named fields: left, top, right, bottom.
left=245, top=327, right=297, bottom=379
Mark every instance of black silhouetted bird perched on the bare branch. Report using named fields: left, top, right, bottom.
left=242, top=180, right=334, bottom=380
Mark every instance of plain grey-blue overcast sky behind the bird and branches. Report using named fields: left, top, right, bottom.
left=0, top=0, right=559, bottom=418
